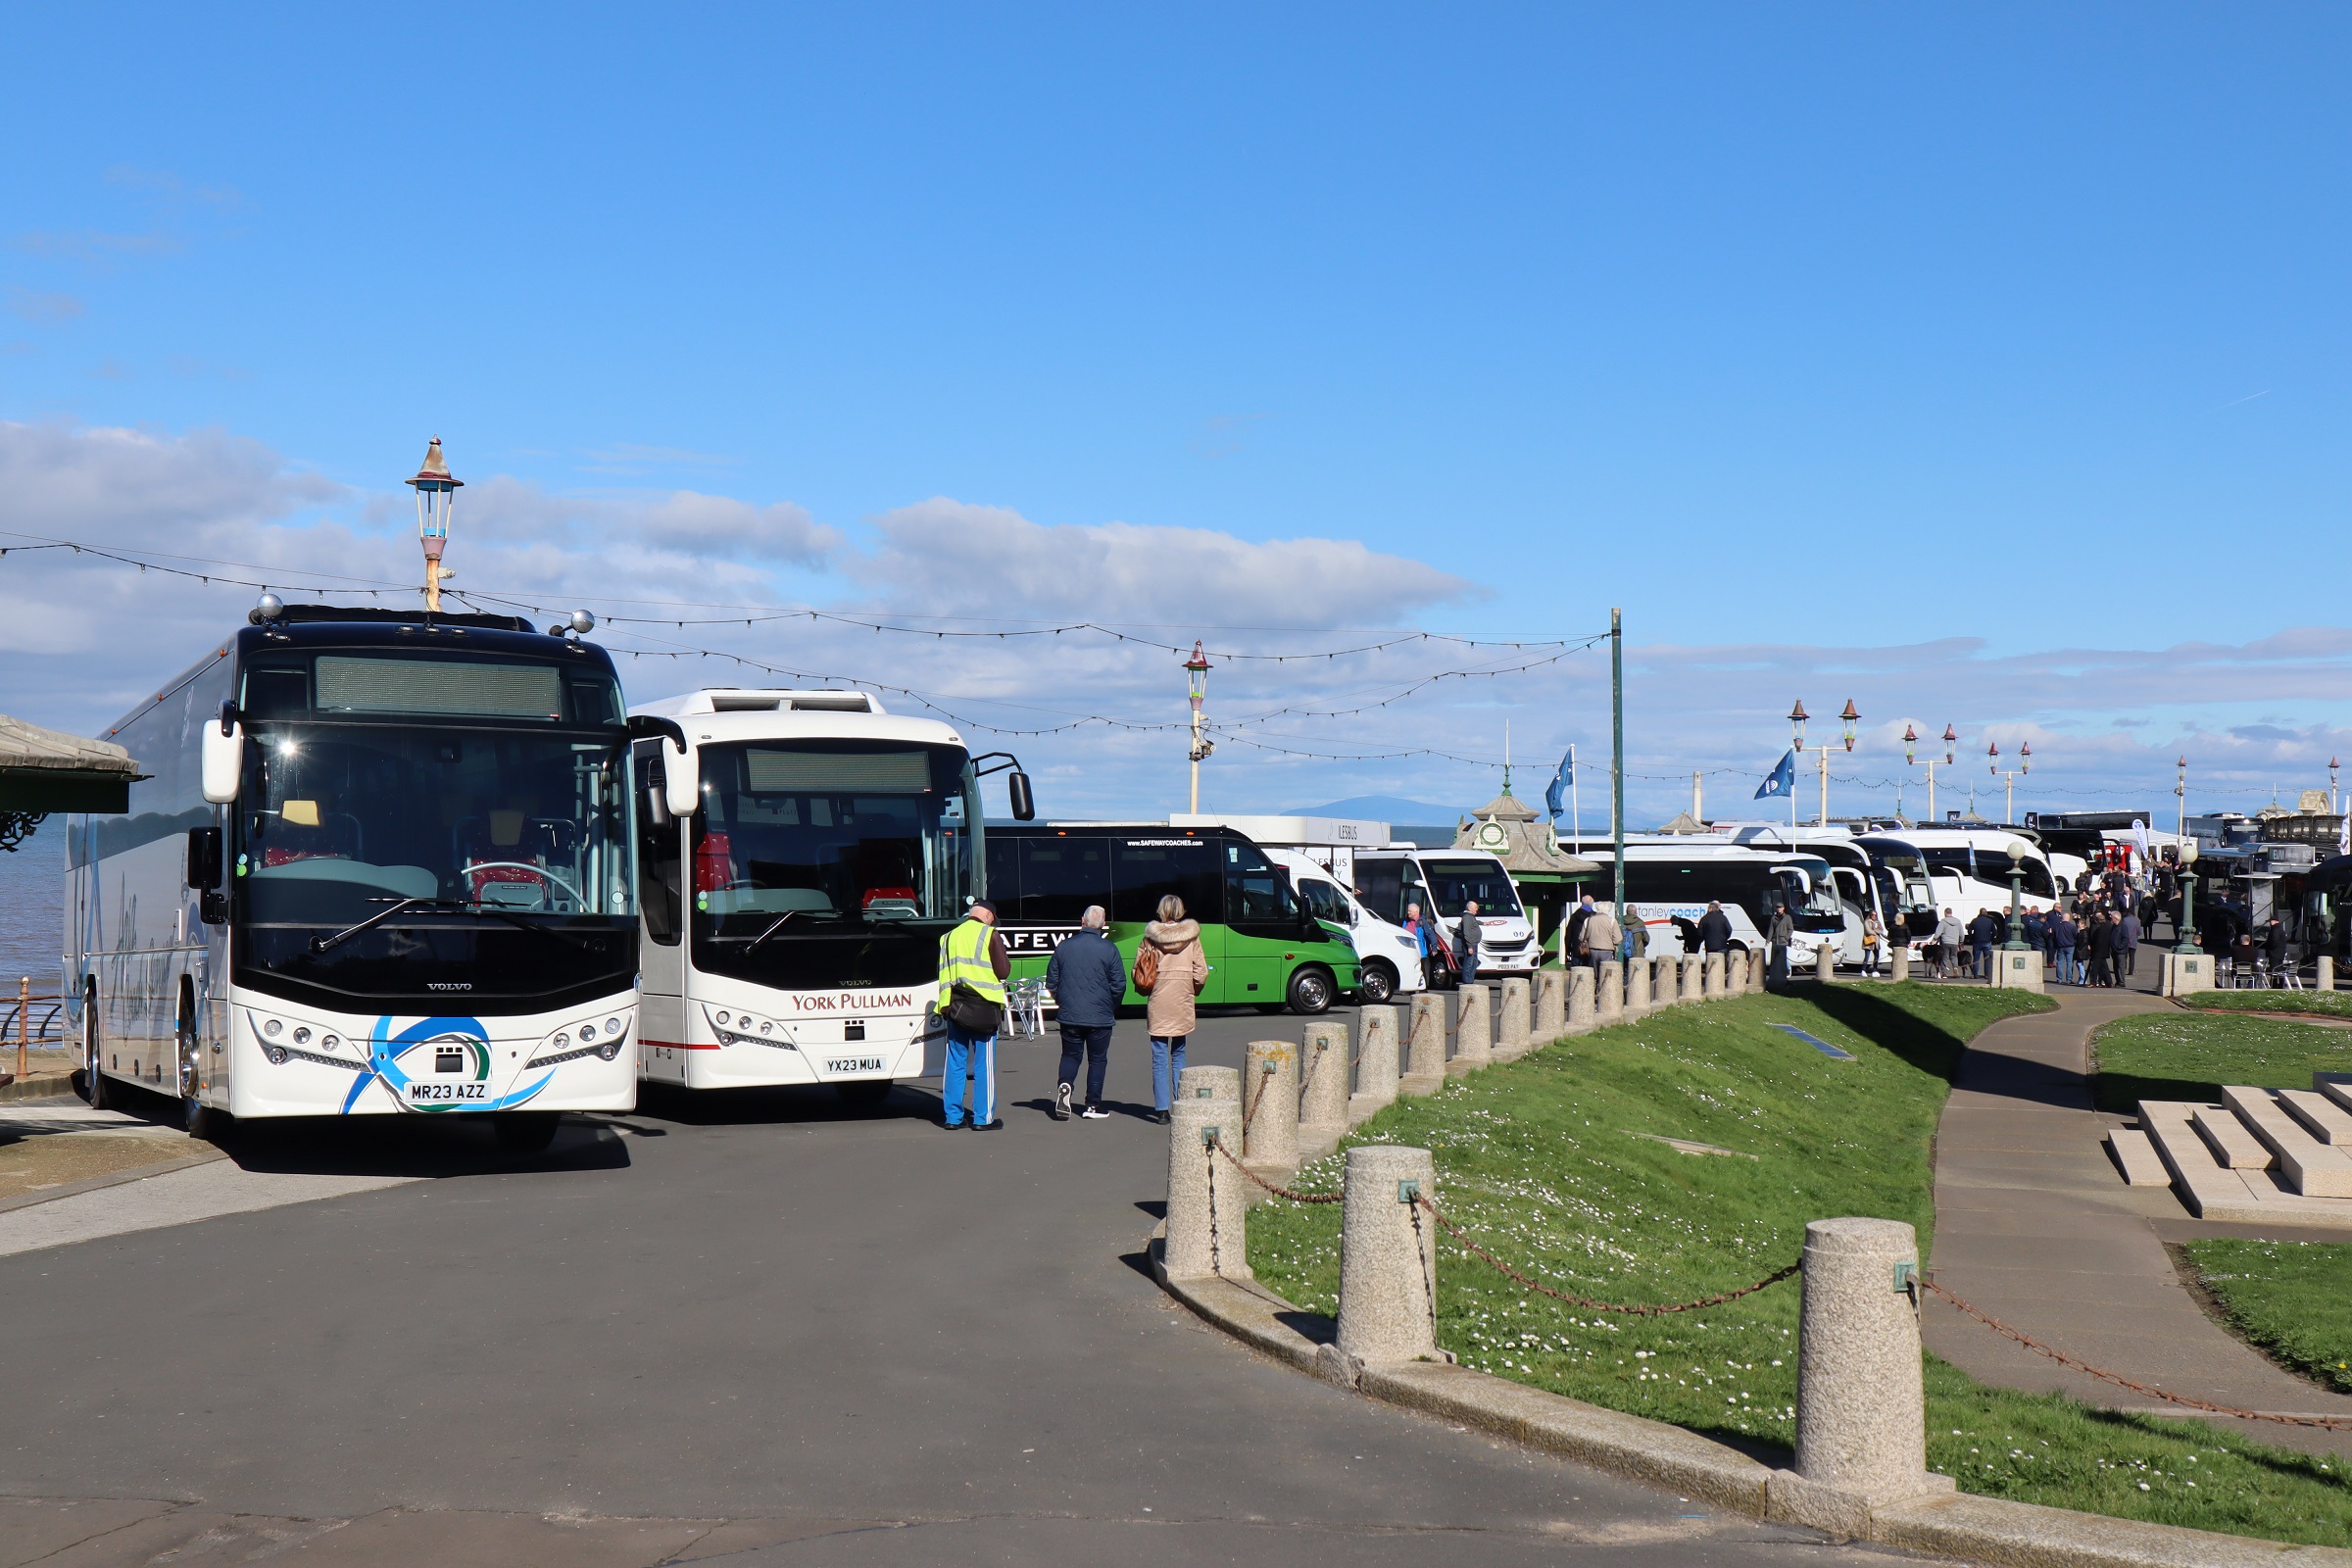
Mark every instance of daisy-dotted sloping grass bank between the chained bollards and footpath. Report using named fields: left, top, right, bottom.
left=1249, top=985, right=2352, bottom=1543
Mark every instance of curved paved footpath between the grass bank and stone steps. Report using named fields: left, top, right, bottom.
left=1922, top=990, right=2352, bottom=1452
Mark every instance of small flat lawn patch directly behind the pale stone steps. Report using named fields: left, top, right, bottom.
left=2091, top=1013, right=2352, bottom=1114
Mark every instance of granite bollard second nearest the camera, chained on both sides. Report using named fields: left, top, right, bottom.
left=1339, top=1143, right=1440, bottom=1382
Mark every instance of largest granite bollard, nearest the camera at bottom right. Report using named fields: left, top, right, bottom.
left=1766, top=1220, right=1952, bottom=1535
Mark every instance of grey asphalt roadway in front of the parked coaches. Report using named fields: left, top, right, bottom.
left=0, top=1015, right=1909, bottom=1568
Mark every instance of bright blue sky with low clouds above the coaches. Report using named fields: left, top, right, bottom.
left=0, top=5, right=2352, bottom=808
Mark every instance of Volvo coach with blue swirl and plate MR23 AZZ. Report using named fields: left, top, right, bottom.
left=66, top=597, right=637, bottom=1148
